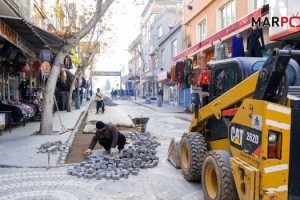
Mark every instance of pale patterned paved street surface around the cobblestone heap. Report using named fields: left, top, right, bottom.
left=0, top=100, right=204, bottom=200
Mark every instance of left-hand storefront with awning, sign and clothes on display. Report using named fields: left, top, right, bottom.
left=0, top=16, right=62, bottom=124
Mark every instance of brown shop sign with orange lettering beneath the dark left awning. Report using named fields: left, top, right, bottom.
left=0, top=21, right=35, bottom=58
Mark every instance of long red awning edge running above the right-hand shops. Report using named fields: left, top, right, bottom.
left=173, top=7, right=266, bottom=61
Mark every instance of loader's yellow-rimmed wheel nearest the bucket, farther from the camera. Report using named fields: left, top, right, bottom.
left=180, top=132, right=207, bottom=181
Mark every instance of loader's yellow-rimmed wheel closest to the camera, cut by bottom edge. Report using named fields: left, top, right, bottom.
left=202, top=151, right=239, bottom=200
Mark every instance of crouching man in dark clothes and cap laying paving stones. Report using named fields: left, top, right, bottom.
left=84, top=121, right=126, bottom=156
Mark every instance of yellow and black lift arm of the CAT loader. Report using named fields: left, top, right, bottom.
left=189, top=49, right=300, bottom=132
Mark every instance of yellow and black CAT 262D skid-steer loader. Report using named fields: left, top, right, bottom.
left=168, top=49, right=300, bottom=200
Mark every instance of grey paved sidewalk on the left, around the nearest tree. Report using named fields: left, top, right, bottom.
left=0, top=102, right=89, bottom=167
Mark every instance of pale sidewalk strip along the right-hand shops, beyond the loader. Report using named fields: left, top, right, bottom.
left=128, top=96, right=192, bottom=122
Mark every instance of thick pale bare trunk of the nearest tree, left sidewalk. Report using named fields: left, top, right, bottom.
left=40, top=51, right=68, bottom=135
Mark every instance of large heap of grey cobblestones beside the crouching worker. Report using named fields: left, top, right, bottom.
left=68, top=132, right=160, bottom=180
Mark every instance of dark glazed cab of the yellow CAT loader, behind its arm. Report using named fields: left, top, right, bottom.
left=203, top=57, right=300, bottom=141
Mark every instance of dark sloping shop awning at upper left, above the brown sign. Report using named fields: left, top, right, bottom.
left=0, top=15, right=63, bottom=50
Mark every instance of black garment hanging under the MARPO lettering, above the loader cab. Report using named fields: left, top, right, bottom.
left=247, top=28, right=265, bottom=57
